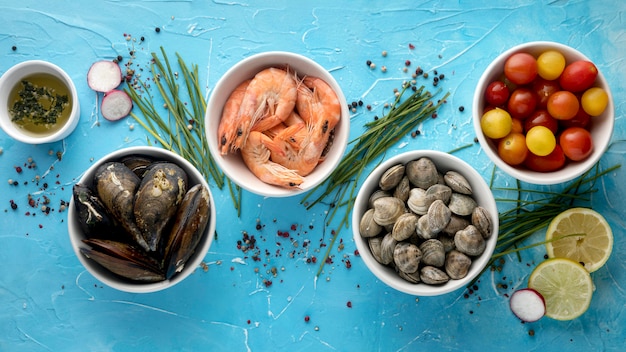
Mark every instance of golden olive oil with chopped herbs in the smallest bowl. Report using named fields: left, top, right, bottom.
left=9, top=73, right=72, bottom=137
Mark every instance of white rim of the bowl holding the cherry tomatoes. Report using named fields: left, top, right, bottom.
left=472, top=41, right=615, bottom=185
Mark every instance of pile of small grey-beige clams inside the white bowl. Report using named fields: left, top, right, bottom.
left=359, top=158, right=493, bottom=285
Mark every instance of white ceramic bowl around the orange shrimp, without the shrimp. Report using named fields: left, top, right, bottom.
left=205, top=51, right=350, bottom=197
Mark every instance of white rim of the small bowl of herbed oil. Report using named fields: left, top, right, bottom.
left=0, top=60, right=80, bottom=144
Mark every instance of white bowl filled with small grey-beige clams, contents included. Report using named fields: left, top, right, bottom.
left=352, top=150, right=498, bottom=296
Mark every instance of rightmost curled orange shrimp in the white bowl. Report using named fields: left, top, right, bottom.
left=267, top=77, right=341, bottom=176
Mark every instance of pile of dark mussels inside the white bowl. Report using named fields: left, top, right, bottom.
left=73, top=156, right=211, bottom=282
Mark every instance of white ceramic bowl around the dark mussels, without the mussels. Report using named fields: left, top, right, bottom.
left=67, top=147, right=216, bottom=293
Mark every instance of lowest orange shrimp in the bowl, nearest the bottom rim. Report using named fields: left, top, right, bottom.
left=241, top=131, right=304, bottom=188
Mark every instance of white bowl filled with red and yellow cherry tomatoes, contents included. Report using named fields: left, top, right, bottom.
left=473, top=41, right=615, bottom=185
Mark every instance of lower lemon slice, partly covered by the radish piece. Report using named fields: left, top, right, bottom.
left=528, top=258, right=594, bottom=320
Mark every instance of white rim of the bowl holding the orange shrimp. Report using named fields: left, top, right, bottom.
left=205, top=51, right=350, bottom=197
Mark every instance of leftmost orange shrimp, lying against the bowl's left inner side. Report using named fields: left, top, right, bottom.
left=217, top=80, right=251, bottom=155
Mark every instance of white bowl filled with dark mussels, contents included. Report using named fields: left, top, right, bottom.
left=68, top=147, right=215, bottom=293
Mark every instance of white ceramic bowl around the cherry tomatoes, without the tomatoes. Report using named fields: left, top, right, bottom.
left=472, top=41, right=615, bottom=185
